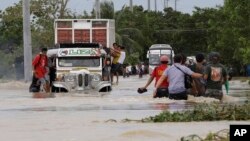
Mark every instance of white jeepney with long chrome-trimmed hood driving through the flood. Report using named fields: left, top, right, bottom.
left=47, top=43, right=112, bottom=92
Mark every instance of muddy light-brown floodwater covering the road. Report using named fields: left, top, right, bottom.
left=0, top=76, right=250, bottom=141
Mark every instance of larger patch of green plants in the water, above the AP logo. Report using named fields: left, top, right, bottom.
left=143, top=102, right=250, bottom=122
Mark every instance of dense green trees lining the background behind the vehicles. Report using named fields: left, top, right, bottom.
left=0, top=0, right=250, bottom=76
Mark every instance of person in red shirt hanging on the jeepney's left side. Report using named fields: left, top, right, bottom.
left=32, top=48, right=49, bottom=92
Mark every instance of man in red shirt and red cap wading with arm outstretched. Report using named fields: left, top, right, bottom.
left=139, top=55, right=168, bottom=98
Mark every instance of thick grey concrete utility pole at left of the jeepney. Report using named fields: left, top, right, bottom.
left=23, top=0, right=32, bottom=82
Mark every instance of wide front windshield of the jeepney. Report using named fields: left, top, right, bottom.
left=58, top=57, right=101, bottom=67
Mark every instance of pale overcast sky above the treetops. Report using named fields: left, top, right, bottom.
left=0, top=0, right=224, bottom=14
